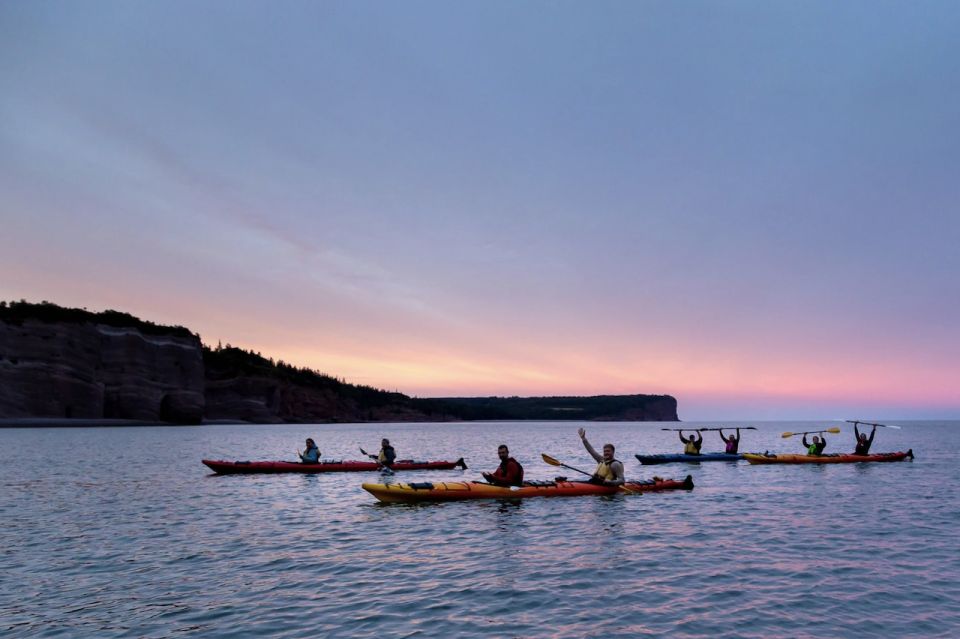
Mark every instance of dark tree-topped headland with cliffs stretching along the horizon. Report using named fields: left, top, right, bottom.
left=0, top=300, right=678, bottom=424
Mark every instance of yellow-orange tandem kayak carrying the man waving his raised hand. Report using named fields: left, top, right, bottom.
left=363, top=475, right=693, bottom=504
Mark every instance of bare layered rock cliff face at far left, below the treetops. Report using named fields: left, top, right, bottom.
left=0, top=319, right=205, bottom=423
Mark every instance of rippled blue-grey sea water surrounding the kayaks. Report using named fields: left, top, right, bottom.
left=0, top=422, right=960, bottom=638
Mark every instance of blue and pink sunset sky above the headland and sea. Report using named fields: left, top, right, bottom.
left=0, top=0, right=960, bottom=420
